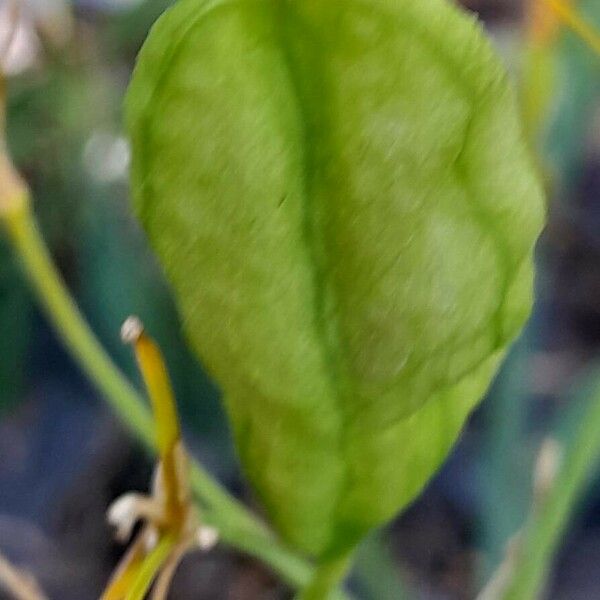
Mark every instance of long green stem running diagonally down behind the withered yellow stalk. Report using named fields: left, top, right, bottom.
left=0, top=194, right=330, bottom=588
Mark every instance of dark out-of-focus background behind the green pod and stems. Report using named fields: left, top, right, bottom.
left=0, top=0, right=600, bottom=600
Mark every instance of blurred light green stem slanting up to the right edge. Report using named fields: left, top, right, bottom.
left=504, top=384, right=600, bottom=600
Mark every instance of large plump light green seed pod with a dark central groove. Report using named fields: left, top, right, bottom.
left=127, top=0, right=544, bottom=558
